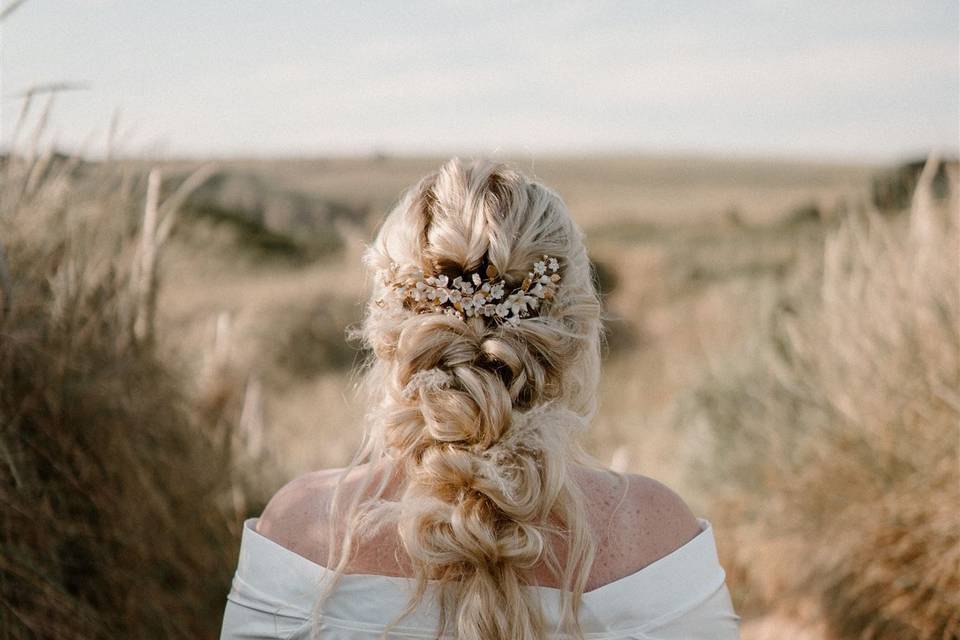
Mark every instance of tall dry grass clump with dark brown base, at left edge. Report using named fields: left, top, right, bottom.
left=0, top=107, right=270, bottom=639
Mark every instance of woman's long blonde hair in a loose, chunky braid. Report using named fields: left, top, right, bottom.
left=326, top=159, right=601, bottom=640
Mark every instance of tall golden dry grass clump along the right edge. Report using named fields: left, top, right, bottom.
left=685, top=159, right=960, bottom=640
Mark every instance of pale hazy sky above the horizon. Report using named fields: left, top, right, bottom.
left=0, top=0, right=960, bottom=161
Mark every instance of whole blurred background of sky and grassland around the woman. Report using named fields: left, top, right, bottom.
left=0, top=0, right=960, bottom=640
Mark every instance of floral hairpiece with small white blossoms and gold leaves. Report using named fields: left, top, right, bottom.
left=377, top=255, right=560, bottom=324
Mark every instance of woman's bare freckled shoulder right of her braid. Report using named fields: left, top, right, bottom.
left=585, top=474, right=700, bottom=584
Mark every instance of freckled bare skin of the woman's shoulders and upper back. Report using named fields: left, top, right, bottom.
left=257, top=460, right=700, bottom=591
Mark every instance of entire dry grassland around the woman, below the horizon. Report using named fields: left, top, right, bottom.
left=0, top=148, right=960, bottom=640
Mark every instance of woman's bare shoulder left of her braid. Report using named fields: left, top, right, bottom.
left=257, top=469, right=341, bottom=561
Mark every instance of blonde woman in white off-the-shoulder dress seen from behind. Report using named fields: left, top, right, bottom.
left=221, top=160, right=739, bottom=640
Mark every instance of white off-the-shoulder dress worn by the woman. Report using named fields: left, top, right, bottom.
left=220, top=519, right=740, bottom=640
